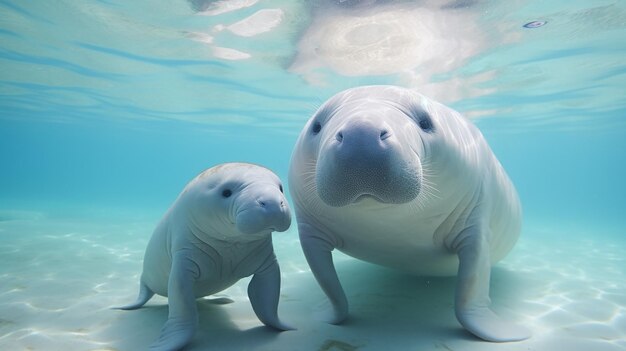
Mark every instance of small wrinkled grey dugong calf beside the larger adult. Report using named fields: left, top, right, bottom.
left=121, top=163, right=293, bottom=350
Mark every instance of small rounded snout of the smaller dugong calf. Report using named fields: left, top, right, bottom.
left=235, top=192, right=291, bottom=234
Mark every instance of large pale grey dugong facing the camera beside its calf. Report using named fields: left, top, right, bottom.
left=289, top=86, right=530, bottom=342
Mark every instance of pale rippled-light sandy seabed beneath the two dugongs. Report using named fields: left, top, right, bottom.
left=0, top=213, right=626, bottom=351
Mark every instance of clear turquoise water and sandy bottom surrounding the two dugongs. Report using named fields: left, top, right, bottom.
left=0, top=0, right=626, bottom=350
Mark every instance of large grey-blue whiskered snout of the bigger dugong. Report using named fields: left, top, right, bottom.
left=316, top=120, right=420, bottom=207
